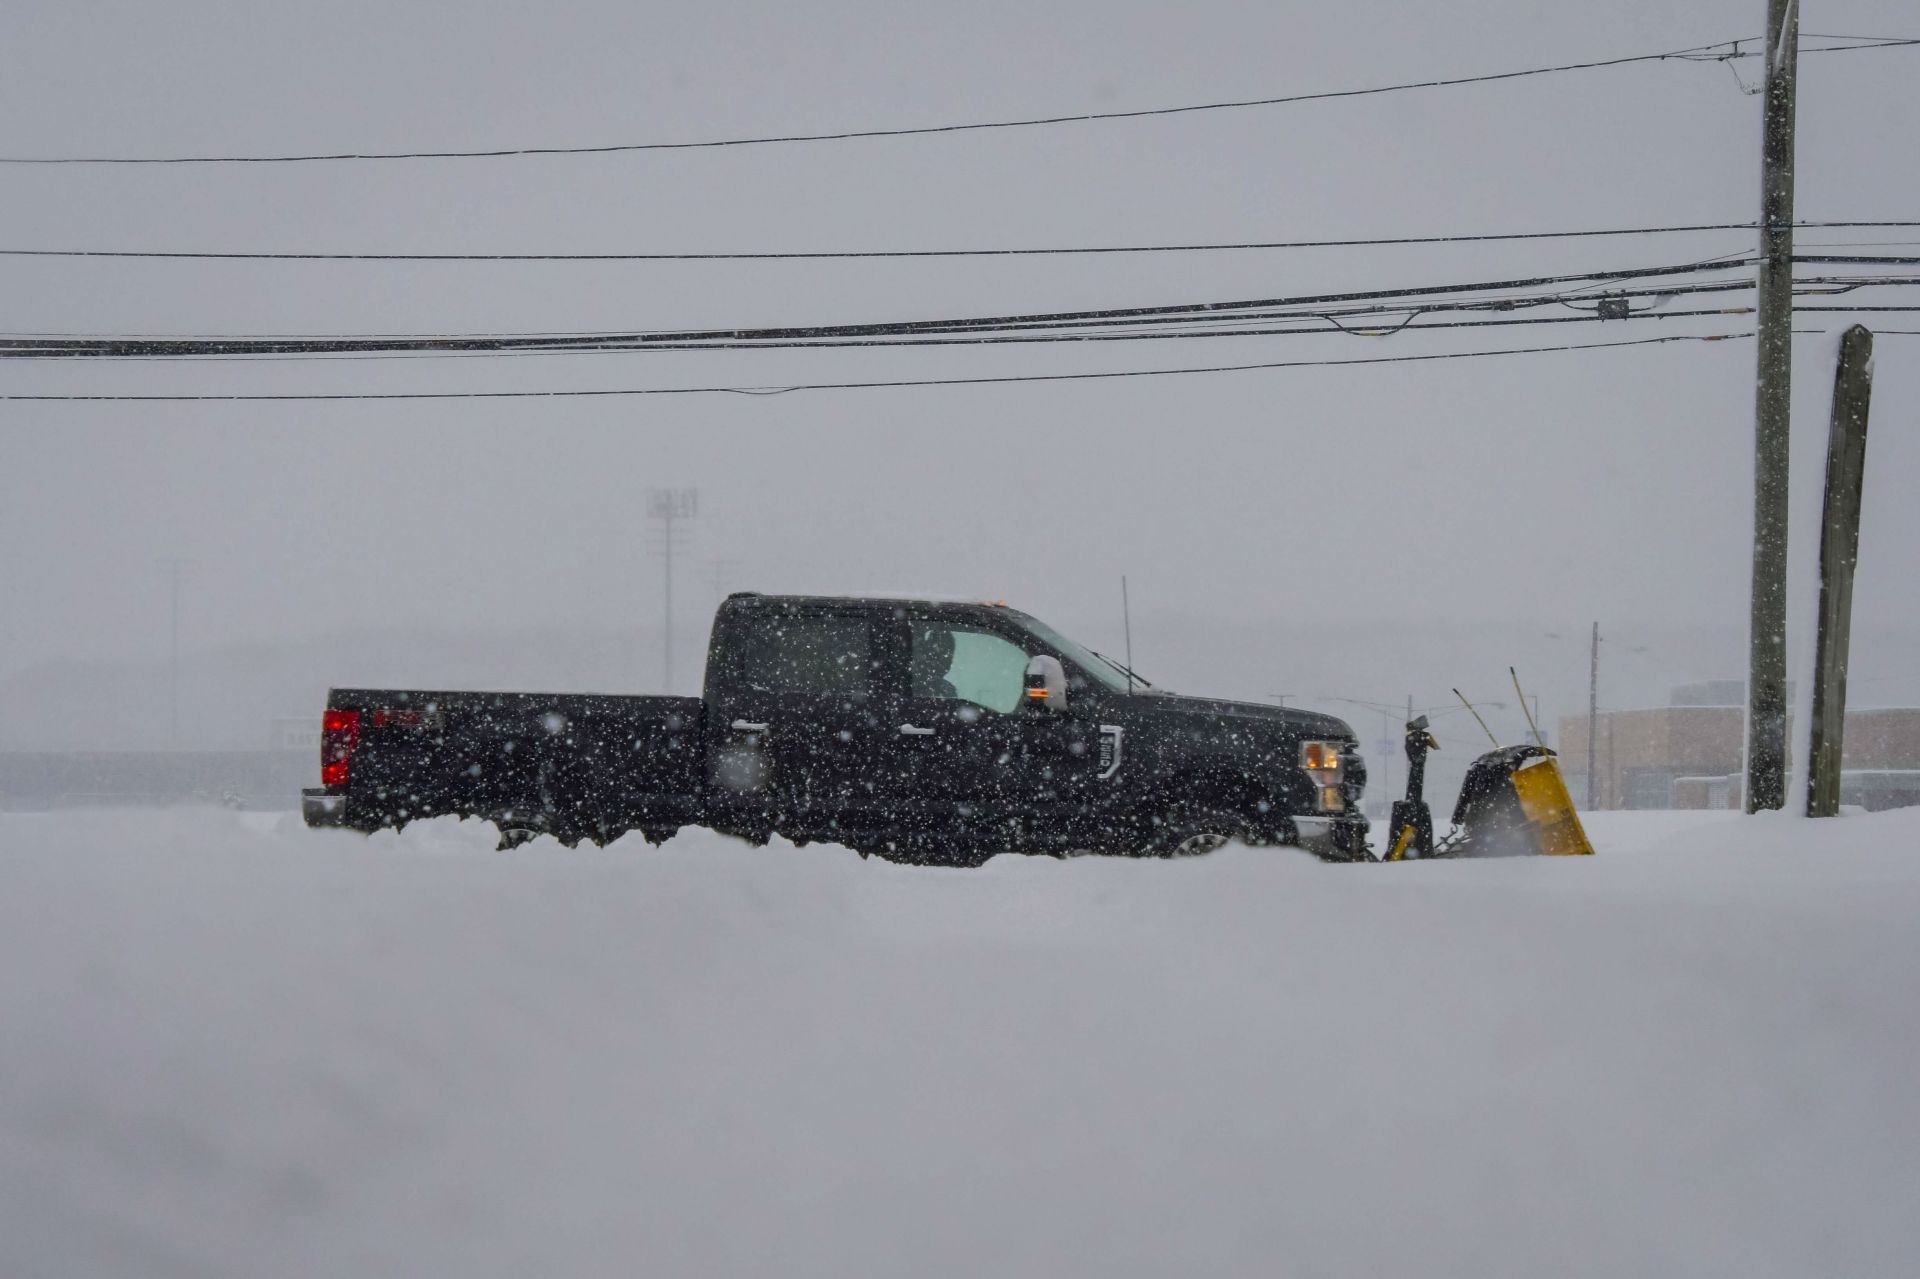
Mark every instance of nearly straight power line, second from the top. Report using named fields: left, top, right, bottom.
left=0, top=221, right=1920, bottom=261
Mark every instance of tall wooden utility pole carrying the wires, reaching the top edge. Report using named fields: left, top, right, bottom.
left=1745, top=0, right=1799, bottom=812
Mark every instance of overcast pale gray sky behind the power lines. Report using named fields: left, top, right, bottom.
left=0, top=0, right=1920, bottom=706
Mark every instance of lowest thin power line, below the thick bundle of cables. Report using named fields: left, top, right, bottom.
left=0, top=330, right=1753, bottom=403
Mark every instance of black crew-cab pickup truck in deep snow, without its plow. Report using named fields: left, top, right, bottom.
left=301, top=593, right=1367, bottom=866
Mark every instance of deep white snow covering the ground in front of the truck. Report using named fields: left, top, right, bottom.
left=0, top=812, right=1920, bottom=1279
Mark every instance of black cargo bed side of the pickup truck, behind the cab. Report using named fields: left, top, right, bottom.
left=326, top=688, right=705, bottom=841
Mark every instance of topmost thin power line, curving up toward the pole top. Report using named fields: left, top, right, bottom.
left=0, top=38, right=1920, bottom=165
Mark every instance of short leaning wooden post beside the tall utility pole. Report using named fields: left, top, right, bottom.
left=1807, top=325, right=1874, bottom=816
